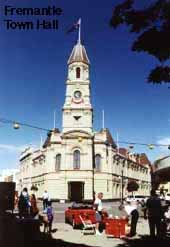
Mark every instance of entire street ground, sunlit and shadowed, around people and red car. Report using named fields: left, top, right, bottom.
left=0, top=201, right=169, bottom=247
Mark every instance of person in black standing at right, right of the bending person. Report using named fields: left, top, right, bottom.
left=145, top=190, right=162, bottom=238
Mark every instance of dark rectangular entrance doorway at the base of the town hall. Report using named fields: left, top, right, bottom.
left=68, top=182, right=84, bottom=202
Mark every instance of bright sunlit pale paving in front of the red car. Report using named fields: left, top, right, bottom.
left=44, top=219, right=149, bottom=247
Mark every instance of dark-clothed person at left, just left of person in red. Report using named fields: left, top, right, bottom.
left=18, top=188, right=30, bottom=218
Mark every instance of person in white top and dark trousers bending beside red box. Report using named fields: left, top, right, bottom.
left=124, top=202, right=139, bottom=237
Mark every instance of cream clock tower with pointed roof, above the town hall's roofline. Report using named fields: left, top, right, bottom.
left=63, top=39, right=93, bottom=133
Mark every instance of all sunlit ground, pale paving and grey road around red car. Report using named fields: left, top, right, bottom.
left=38, top=202, right=149, bottom=247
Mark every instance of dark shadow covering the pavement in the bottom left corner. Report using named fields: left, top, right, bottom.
left=0, top=214, right=98, bottom=247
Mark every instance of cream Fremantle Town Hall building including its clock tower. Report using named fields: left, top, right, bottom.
left=17, top=38, right=151, bottom=201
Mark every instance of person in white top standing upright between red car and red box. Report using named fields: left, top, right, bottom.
left=94, top=192, right=103, bottom=235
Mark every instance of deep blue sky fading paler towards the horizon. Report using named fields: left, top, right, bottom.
left=0, top=0, right=170, bottom=169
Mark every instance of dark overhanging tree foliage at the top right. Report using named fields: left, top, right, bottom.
left=110, top=0, right=170, bottom=84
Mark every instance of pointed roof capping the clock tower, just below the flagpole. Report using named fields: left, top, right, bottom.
left=67, top=43, right=90, bottom=65
